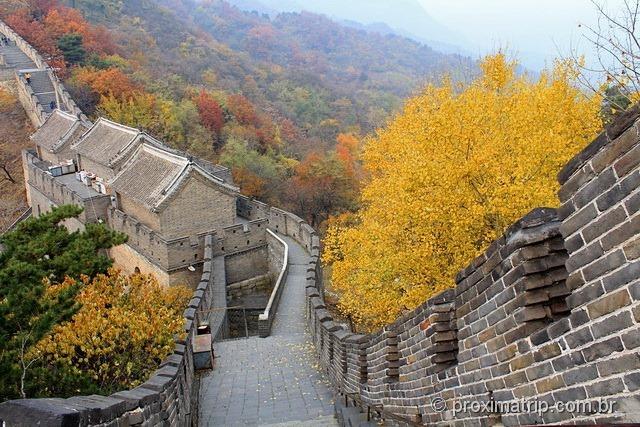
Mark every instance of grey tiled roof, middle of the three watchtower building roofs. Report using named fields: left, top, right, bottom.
left=72, top=118, right=140, bottom=166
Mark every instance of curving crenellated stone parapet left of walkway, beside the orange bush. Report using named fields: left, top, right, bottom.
left=0, top=236, right=224, bottom=427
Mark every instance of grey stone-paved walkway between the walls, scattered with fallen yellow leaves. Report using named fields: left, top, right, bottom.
left=199, top=236, right=337, bottom=427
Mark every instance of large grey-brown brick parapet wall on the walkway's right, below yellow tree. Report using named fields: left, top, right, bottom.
left=296, top=107, right=640, bottom=426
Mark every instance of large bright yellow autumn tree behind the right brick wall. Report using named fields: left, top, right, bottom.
left=324, top=54, right=601, bottom=329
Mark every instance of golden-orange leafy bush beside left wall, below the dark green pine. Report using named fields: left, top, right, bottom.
left=28, top=269, right=191, bottom=395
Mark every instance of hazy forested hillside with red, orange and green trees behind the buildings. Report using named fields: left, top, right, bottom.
left=3, top=0, right=475, bottom=226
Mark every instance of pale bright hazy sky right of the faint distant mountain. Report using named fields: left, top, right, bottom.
left=419, top=0, right=623, bottom=68
